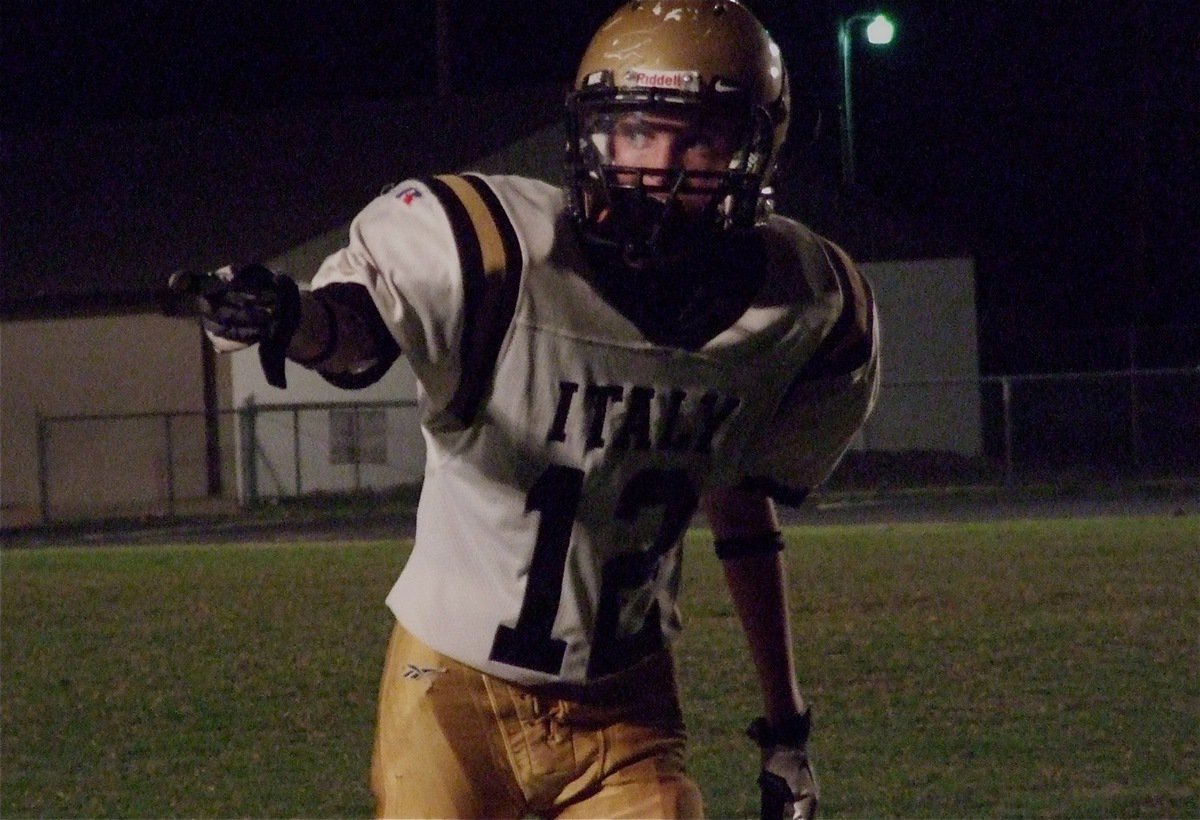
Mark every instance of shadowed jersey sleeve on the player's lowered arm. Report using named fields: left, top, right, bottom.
left=743, top=240, right=880, bottom=505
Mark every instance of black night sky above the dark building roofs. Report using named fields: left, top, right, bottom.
left=0, top=0, right=1200, bottom=369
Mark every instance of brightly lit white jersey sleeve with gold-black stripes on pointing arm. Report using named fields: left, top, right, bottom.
left=313, top=170, right=523, bottom=424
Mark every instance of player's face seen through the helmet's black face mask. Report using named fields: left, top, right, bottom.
left=610, top=112, right=738, bottom=210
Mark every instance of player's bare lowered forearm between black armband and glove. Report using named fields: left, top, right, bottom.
left=721, top=552, right=804, bottom=724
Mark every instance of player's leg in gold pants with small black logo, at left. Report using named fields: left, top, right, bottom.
left=371, top=624, right=524, bottom=818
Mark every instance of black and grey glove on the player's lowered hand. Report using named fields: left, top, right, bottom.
left=746, top=708, right=821, bottom=820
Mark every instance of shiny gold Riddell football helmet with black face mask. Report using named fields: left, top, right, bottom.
left=566, top=0, right=790, bottom=268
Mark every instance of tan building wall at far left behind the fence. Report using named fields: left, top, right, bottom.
left=0, top=316, right=228, bottom=526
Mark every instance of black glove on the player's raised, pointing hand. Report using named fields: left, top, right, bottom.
left=168, top=264, right=300, bottom=388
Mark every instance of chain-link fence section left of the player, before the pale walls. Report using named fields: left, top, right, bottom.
left=37, top=401, right=425, bottom=522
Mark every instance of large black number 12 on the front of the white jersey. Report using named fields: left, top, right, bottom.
left=491, top=465, right=697, bottom=677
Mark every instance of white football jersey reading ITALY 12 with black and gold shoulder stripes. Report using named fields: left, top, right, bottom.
left=313, top=174, right=878, bottom=683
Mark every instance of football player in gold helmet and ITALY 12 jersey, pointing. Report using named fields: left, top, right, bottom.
left=189, top=0, right=878, bottom=818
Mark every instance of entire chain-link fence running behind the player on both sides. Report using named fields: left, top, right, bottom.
left=37, top=369, right=1200, bottom=522
